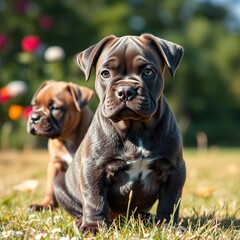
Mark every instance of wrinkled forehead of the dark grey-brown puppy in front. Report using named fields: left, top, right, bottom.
left=97, top=36, right=162, bottom=68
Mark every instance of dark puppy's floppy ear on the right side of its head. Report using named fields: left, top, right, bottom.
left=142, top=34, right=184, bottom=76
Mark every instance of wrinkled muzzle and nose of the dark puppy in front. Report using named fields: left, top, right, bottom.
left=102, top=84, right=156, bottom=121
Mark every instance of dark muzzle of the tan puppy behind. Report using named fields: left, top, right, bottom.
left=28, top=117, right=61, bottom=138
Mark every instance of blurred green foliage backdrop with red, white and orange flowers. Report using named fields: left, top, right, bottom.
left=0, top=0, right=240, bottom=149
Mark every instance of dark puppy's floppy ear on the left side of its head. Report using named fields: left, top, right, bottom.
left=77, top=35, right=116, bottom=81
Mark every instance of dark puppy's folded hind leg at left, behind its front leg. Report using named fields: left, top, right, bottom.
left=54, top=172, right=82, bottom=223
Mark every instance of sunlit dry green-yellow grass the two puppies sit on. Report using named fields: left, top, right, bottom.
left=0, top=148, right=240, bottom=240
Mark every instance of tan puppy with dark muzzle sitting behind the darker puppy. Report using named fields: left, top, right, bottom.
left=27, top=81, right=93, bottom=211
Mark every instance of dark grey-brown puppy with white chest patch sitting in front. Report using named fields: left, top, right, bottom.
left=54, top=34, right=186, bottom=231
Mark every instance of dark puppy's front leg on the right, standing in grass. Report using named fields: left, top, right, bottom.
left=156, top=162, right=186, bottom=224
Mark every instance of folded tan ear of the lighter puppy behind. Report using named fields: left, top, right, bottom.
left=68, top=83, right=94, bottom=111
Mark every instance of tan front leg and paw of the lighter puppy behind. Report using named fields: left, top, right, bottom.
left=29, top=159, right=67, bottom=212
